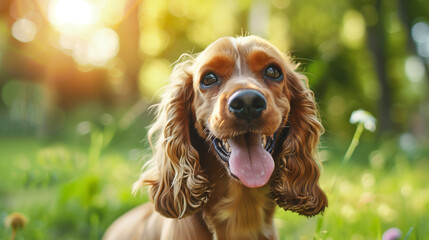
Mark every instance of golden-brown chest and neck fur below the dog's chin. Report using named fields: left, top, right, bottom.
left=202, top=154, right=277, bottom=240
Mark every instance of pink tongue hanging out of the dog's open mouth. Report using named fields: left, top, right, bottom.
left=228, top=133, right=274, bottom=188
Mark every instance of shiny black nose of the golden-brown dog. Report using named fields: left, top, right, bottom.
left=228, top=89, right=267, bottom=122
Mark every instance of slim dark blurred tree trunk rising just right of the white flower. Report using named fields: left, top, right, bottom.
left=367, top=0, right=393, bottom=132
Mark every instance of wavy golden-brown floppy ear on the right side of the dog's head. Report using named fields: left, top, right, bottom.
left=272, top=65, right=328, bottom=216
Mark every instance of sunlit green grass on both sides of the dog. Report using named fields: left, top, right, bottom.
left=0, top=130, right=429, bottom=239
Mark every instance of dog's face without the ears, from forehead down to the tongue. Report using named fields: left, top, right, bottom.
left=192, top=37, right=291, bottom=187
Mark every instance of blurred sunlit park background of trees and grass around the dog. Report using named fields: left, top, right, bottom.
left=0, top=0, right=429, bottom=240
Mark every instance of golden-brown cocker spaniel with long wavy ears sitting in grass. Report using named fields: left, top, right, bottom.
left=105, top=36, right=327, bottom=240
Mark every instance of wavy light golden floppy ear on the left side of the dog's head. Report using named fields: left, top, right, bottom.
left=134, top=57, right=210, bottom=218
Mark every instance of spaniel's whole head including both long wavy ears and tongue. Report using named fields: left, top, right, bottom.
left=137, top=36, right=327, bottom=217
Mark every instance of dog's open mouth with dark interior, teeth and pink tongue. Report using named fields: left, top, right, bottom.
left=213, top=133, right=275, bottom=188
